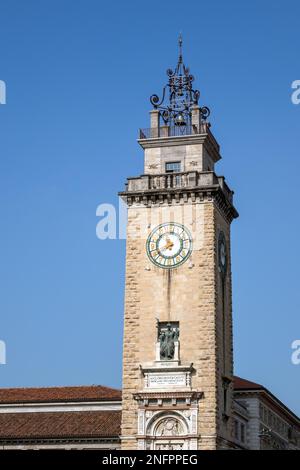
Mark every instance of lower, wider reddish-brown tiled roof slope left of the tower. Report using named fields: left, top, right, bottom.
left=0, top=411, right=121, bottom=439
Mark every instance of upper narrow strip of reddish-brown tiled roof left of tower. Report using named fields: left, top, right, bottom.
left=0, top=385, right=121, bottom=404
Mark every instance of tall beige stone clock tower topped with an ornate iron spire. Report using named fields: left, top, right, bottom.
left=120, top=38, right=238, bottom=450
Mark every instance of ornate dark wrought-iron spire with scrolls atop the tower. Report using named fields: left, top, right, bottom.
left=150, top=34, right=210, bottom=126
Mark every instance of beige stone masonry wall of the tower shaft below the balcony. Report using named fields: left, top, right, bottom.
left=122, top=201, right=232, bottom=449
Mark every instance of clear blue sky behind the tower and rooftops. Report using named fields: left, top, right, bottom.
left=0, top=0, right=300, bottom=413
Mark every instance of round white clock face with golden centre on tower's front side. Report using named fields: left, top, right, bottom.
left=146, top=222, right=192, bottom=269
